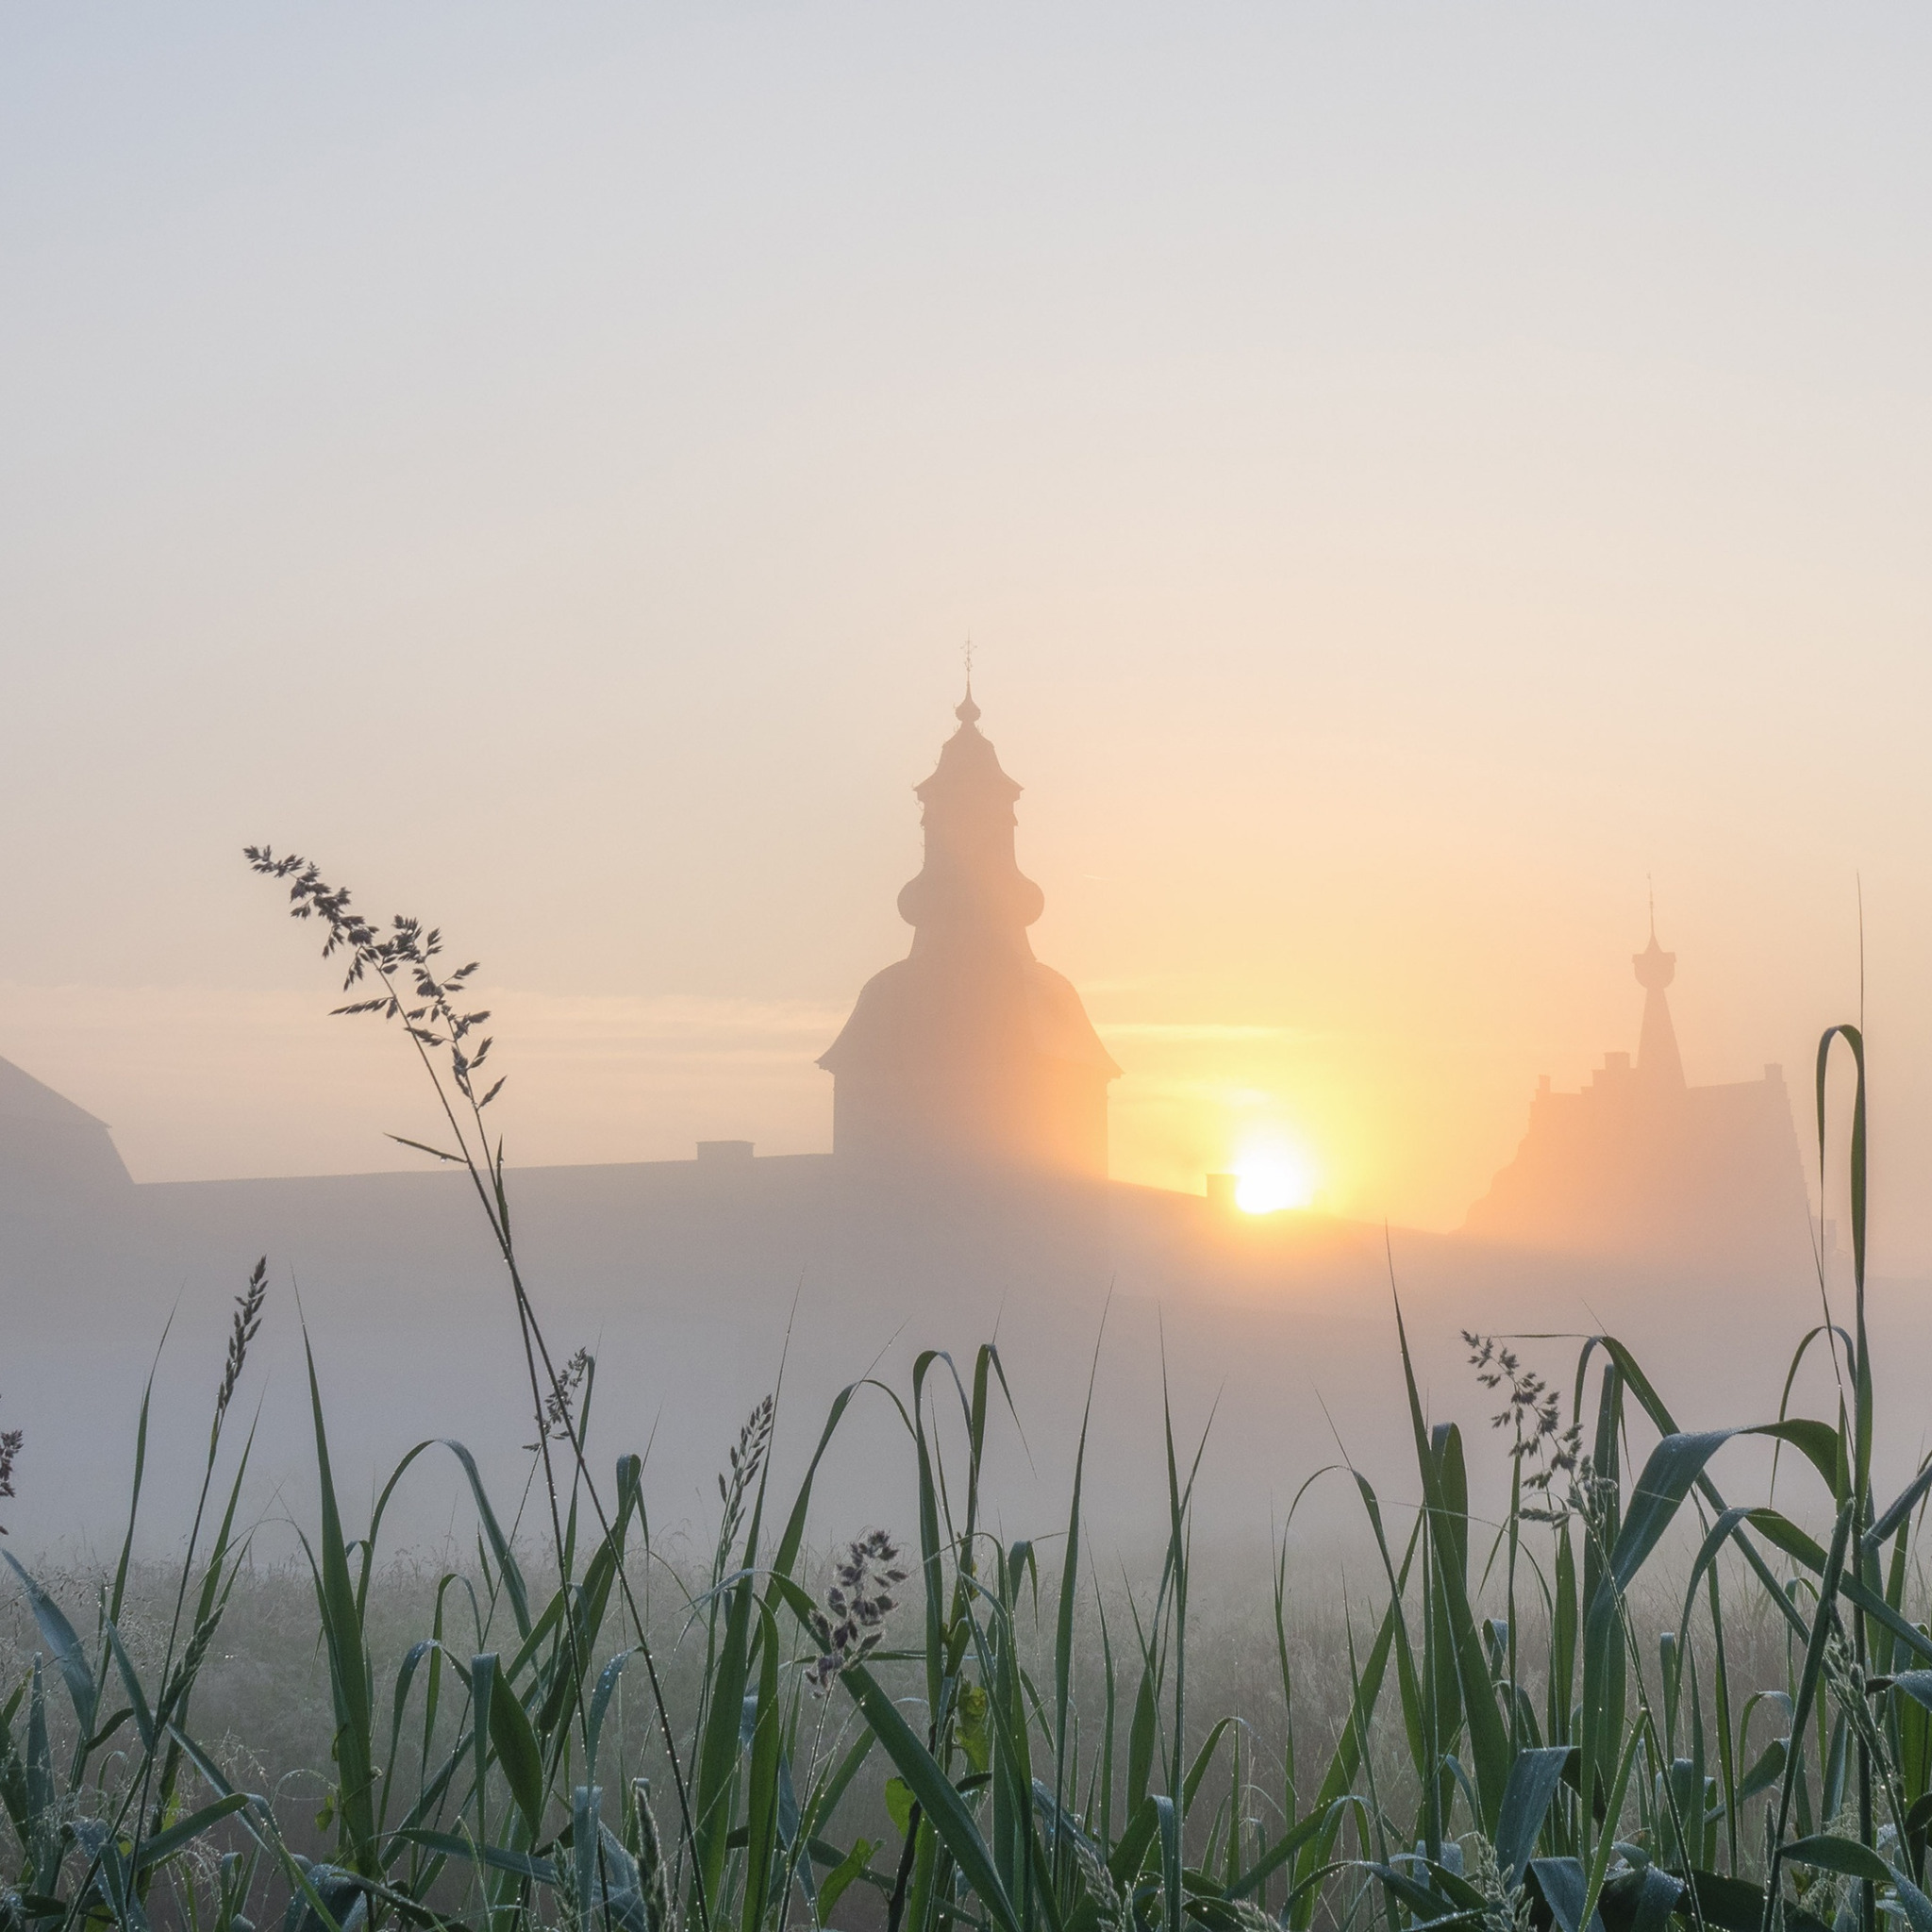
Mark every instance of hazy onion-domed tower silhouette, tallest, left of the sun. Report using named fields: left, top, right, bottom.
left=819, top=680, right=1121, bottom=1180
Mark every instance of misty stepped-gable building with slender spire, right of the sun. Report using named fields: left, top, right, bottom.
left=1462, top=918, right=1812, bottom=1275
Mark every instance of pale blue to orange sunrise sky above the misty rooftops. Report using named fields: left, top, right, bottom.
left=0, top=0, right=1932, bottom=1274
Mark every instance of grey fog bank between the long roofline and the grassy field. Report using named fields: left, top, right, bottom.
left=4, top=1161, right=1901, bottom=1561
